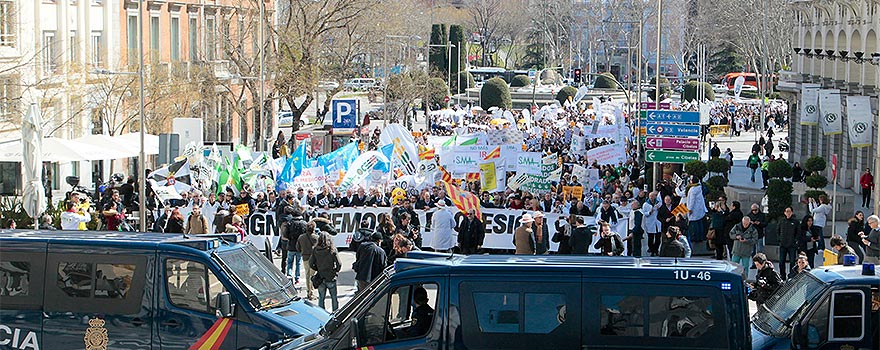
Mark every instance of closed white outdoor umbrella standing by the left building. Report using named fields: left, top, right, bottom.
left=21, top=104, right=46, bottom=224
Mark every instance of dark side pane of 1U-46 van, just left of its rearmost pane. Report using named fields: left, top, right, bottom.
left=599, top=295, right=645, bottom=337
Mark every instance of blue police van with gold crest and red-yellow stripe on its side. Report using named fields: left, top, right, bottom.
left=0, top=231, right=329, bottom=349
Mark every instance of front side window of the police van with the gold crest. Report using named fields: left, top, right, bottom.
left=165, top=259, right=226, bottom=313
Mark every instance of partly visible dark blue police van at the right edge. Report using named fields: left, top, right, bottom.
left=752, top=264, right=880, bottom=350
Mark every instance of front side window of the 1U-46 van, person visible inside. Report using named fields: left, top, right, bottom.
left=358, top=284, right=438, bottom=346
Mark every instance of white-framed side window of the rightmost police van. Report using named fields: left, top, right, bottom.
left=830, top=290, right=865, bottom=341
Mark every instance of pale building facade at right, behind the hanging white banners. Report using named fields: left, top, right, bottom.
left=778, top=0, right=880, bottom=190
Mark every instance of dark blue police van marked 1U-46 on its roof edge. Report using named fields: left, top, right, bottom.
left=278, top=252, right=751, bottom=350
